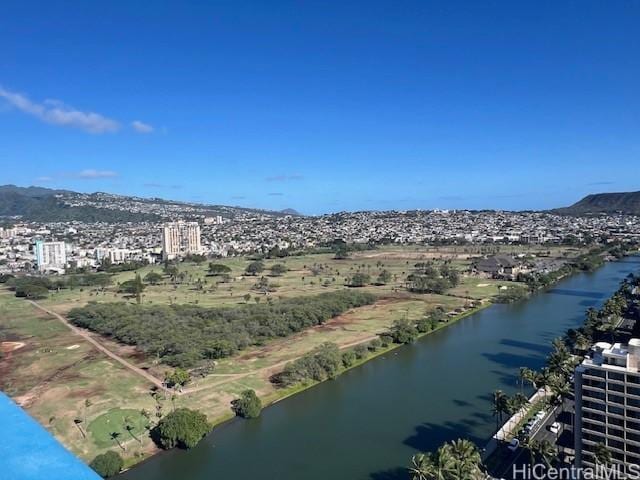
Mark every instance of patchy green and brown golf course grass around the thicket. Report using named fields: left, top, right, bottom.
left=0, top=246, right=574, bottom=463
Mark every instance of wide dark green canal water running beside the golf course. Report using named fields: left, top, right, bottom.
left=120, top=257, right=640, bottom=480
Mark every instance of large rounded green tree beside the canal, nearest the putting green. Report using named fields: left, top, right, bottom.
left=152, top=408, right=211, bottom=449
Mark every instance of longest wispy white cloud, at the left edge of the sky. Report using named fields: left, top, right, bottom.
left=0, top=87, right=120, bottom=133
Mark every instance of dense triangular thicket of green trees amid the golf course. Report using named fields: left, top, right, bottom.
left=69, top=290, right=376, bottom=367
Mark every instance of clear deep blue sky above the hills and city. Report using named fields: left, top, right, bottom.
left=0, top=0, right=640, bottom=214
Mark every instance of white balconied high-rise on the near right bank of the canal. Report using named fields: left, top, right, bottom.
left=574, top=338, right=640, bottom=468
